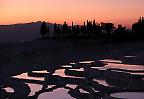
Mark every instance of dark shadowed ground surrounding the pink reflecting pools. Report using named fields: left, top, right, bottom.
left=0, top=40, right=144, bottom=99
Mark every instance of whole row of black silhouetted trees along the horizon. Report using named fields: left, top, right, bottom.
left=40, top=17, right=144, bottom=42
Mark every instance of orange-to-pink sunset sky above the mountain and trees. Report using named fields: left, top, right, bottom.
left=0, top=0, right=144, bottom=26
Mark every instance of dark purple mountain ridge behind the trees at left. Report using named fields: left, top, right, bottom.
left=0, top=21, right=54, bottom=42
